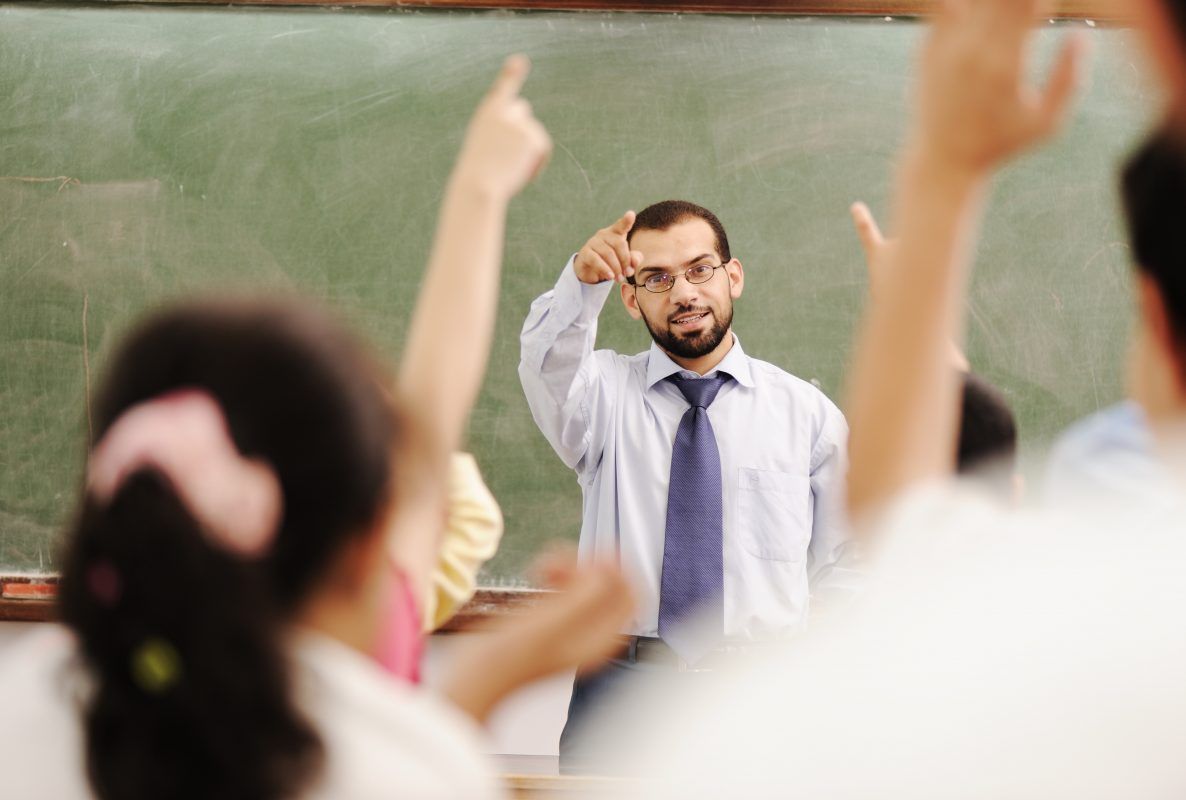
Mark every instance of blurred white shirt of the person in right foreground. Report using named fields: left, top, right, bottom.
left=611, top=486, right=1186, bottom=800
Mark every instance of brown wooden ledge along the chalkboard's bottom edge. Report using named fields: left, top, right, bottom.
left=0, top=575, right=547, bottom=633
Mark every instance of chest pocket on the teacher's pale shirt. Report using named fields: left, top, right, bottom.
left=738, top=467, right=815, bottom=562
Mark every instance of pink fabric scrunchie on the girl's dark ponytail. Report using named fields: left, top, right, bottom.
left=87, top=389, right=283, bottom=556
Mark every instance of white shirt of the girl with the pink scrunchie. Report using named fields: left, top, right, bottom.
left=0, top=625, right=503, bottom=800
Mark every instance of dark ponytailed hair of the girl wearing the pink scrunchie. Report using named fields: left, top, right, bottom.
left=59, top=302, right=400, bottom=798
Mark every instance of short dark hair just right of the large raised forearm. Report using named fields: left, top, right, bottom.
left=956, top=372, right=1018, bottom=498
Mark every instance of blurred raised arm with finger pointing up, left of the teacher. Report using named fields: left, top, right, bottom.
left=391, top=56, right=551, bottom=597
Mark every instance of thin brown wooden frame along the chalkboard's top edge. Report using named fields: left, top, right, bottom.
left=90, top=0, right=1131, bottom=23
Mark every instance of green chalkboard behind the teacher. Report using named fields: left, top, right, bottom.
left=0, top=5, right=1152, bottom=584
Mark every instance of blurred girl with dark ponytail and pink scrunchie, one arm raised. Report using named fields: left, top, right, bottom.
left=0, top=58, right=630, bottom=800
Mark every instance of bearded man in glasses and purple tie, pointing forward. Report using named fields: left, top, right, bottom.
left=519, top=200, right=847, bottom=768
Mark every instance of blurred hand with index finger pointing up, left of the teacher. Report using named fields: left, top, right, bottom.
left=454, top=56, right=551, bottom=199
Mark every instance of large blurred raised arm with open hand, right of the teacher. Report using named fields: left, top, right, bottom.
left=846, top=0, right=1085, bottom=519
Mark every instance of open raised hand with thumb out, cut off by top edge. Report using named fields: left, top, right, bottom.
left=913, top=0, right=1086, bottom=178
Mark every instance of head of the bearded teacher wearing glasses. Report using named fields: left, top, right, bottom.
left=621, top=200, right=744, bottom=361
